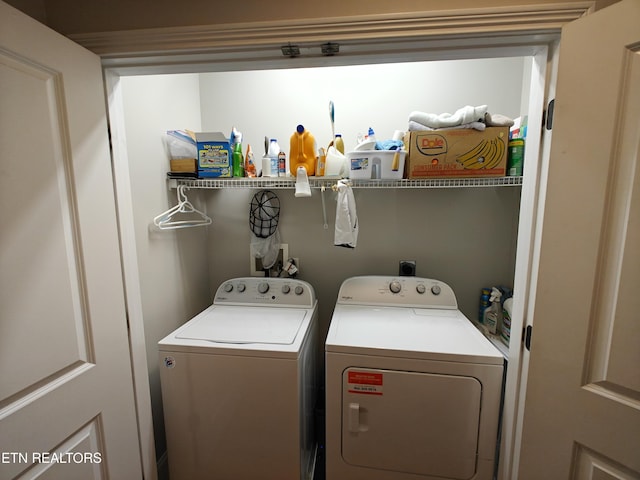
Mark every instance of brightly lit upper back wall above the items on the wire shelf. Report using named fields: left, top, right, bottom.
left=201, top=58, right=524, bottom=155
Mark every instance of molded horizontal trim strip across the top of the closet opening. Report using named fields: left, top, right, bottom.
left=69, top=1, right=595, bottom=58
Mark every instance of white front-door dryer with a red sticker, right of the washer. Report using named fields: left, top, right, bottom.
left=325, top=276, right=504, bottom=480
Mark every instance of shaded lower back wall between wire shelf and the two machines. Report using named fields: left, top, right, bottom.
left=208, top=187, right=520, bottom=340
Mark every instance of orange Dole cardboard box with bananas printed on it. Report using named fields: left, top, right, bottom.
left=404, top=127, right=509, bottom=179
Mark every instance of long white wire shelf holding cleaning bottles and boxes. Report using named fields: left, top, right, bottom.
left=169, top=177, right=522, bottom=190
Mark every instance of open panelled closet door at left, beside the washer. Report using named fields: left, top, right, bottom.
left=0, top=2, right=142, bottom=480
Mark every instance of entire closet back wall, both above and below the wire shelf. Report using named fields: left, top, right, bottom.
left=200, top=58, right=525, bottom=338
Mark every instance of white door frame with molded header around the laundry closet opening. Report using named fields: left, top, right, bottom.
left=94, top=1, right=584, bottom=478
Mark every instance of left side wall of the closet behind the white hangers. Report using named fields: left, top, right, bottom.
left=121, top=75, right=210, bottom=466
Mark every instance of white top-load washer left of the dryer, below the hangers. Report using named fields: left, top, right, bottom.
left=158, top=277, right=318, bottom=480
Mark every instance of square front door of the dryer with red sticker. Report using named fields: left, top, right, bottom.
left=342, top=367, right=482, bottom=479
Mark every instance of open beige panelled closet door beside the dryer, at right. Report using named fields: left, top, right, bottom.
left=509, top=0, right=640, bottom=480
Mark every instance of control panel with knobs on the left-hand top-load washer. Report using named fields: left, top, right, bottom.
left=213, top=277, right=316, bottom=308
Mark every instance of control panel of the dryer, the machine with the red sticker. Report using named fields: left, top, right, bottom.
left=337, top=275, right=458, bottom=309
